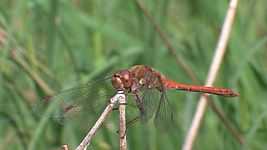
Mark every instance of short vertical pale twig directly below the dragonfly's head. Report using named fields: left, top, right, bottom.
left=119, top=91, right=127, bottom=150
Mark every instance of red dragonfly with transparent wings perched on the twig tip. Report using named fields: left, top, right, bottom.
left=37, top=65, right=239, bottom=127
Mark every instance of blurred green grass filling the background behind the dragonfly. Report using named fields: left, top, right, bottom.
left=0, top=0, right=267, bottom=150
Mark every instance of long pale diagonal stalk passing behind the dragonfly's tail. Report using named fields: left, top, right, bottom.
left=183, top=0, right=238, bottom=150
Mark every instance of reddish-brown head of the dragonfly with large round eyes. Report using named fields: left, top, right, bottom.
left=112, top=70, right=133, bottom=91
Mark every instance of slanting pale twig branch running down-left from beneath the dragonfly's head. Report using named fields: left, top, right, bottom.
left=76, top=91, right=125, bottom=150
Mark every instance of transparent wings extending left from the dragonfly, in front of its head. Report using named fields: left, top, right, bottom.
left=34, top=80, right=115, bottom=124
